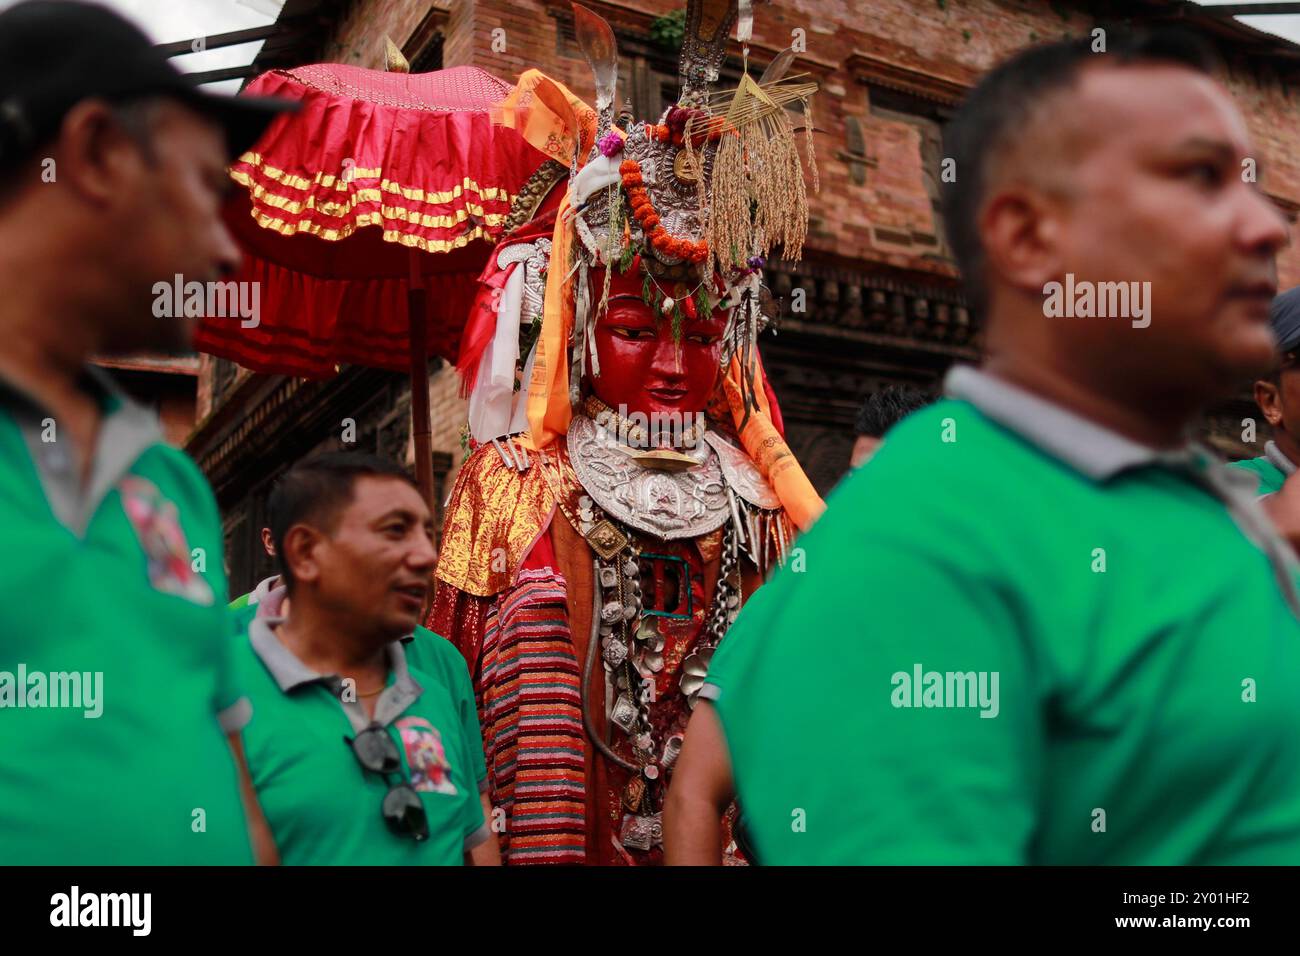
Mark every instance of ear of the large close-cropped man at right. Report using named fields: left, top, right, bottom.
left=979, top=185, right=1062, bottom=295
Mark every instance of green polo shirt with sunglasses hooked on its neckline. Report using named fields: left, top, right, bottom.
left=235, top=605, right=490, bottom=866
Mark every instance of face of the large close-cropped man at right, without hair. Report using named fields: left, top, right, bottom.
left=998, top=65, right=1287, bottom=398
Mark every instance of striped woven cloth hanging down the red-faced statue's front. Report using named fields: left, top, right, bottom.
left=480, top=568, right=586, bottom=865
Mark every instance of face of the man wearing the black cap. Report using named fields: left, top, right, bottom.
left=105, top=100, right=239, bottom=351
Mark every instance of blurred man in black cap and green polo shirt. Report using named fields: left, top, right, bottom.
left=0, top=3, right=292, bottom=864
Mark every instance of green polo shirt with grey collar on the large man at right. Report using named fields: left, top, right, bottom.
left=705, top=369, right=1300, bottom=865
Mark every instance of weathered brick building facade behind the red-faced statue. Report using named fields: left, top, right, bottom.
left=192, top=0, right=1300, bottom=590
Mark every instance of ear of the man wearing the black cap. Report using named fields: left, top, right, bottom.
left=56, top=99, right=147, bottom=208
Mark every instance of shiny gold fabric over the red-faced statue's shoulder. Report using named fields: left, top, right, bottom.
left=437, top=445, right=555, bottom=597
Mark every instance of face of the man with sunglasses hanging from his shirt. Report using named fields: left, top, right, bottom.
left=312, top=476, right=437, bottom=640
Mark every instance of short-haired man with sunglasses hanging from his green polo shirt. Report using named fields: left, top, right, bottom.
left=237, top=451, right=499, bottom=865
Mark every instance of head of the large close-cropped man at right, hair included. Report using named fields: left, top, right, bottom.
left=945, top=27, right=1287, bottom=410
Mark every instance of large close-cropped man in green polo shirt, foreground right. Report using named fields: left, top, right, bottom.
left=673, top=29, right=1300, bottom=864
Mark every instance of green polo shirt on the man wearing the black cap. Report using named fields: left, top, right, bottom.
left=0, top=369, right=252, bottom=865
